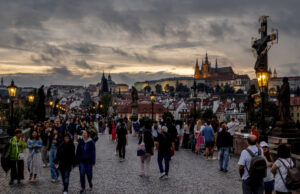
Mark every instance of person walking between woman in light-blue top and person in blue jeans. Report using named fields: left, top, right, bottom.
left=41, top=121, right=51, bottom=168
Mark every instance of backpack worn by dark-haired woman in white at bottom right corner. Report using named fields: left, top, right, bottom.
left=278, top=159, right=300, bottom=190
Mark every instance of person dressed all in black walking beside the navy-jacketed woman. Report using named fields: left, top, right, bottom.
left=53, top=134, right=76, bottom=194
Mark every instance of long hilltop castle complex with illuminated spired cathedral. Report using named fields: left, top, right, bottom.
left=134, top=53, right=250, bottom=91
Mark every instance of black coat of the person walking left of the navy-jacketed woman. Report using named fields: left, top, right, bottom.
left=53, top=142, right=76, bottom=171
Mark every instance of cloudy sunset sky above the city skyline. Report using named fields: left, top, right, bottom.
left=0, top=0, right=300, bottom=86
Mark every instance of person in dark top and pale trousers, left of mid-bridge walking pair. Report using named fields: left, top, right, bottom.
left=139, top=125, right=154, bottom=177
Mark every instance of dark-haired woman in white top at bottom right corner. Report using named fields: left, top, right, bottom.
left=271, top=144, right=294, bottom=194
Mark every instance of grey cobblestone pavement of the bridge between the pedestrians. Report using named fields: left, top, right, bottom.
left=0, top=135, right=241, bottom=194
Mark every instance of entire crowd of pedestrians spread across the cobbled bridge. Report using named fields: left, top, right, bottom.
left=2, top=115, right=300, bottom=194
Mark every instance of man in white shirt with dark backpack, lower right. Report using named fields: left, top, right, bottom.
left=238, top=135, right=264, bottom=194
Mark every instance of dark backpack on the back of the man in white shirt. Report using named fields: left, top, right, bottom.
left=246, top=148, right=267, bottom=180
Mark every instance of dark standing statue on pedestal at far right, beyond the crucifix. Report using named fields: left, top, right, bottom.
left=277, top=77, right=292, bottom=123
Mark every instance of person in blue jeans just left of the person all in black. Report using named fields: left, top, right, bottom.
left=48, top=128, right=61, bottom=183
